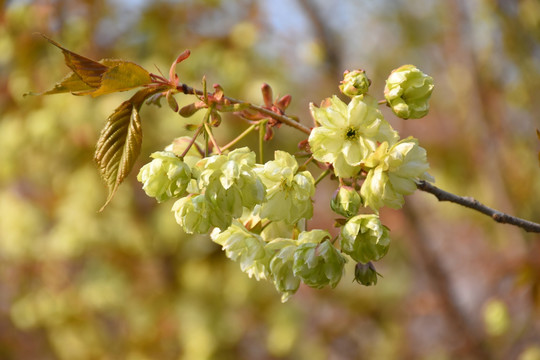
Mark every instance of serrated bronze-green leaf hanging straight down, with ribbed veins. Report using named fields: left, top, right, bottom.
left=94, top=89, right=162, bottom=211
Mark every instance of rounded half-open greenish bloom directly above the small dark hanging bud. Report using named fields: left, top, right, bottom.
left=341, top=214, right=390, bottom=263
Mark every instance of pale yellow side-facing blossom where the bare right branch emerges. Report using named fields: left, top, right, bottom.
left=360, top=137, right=433, bottom=210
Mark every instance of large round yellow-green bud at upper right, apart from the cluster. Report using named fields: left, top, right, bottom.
left=384, top=65, right=434, bottom=119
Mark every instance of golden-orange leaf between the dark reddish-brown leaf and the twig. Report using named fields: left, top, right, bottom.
left=89, top=60, right=152, bottom=97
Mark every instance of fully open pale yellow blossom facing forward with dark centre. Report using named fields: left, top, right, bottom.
left=309, top=95, right=399, bottom=178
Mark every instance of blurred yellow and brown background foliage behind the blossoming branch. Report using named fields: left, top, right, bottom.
left=0, top=0, right=540, bottom=360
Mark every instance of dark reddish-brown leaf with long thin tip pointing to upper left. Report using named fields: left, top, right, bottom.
left=41, top=34, right=109, bottom=88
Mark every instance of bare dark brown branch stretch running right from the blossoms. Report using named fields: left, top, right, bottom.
left=416, top=180, right=540, bottom=233
